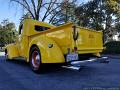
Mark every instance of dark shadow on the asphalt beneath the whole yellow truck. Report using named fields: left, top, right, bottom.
left=5, top=56, right=96, bottom=76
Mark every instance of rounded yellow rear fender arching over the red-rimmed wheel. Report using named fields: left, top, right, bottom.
left=29, top=35, right=65, bottom=63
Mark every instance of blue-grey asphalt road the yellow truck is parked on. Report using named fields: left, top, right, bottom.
left=0, top=56, right=120, bottom=90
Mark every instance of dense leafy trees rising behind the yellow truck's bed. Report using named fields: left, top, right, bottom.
left=52, top=0, right=120, bottom=42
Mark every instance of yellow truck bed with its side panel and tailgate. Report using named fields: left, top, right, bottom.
left=46, top=23, right=103, bottom=54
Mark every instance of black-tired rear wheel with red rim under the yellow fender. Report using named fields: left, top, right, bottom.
left=30, top=46, right=41, bottom=73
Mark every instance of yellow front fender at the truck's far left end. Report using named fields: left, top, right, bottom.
left=5, top=44, right=19, bottom=59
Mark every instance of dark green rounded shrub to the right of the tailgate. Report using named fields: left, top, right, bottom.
left=103, top=41, right=120, bottom=54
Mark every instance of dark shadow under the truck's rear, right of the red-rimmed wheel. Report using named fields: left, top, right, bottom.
left=39, top=65, right=96, bottom=76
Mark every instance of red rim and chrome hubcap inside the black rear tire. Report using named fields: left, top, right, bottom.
left=32, top=50, right=40, bottom=69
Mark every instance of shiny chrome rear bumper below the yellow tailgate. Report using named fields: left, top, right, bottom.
left=70, top=57, right=109, bottom=66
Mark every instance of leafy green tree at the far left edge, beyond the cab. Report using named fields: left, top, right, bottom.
left=0, top=19, right=16, bottom=47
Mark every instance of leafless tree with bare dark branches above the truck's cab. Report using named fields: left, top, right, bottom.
left=10, top=0, right=60, bottom=21
